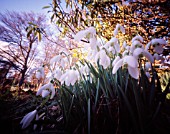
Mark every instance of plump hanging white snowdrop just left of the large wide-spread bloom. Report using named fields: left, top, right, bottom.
left=95, top=49, right=110, bottom=69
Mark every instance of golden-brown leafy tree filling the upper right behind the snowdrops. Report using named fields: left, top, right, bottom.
left=46, top=0, right=170, bottom=42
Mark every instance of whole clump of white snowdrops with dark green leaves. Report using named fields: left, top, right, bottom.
left=21, top=24, right=168, bottom=133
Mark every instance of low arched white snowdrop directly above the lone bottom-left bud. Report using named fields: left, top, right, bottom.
left=36, top=83, right=55, bottom=99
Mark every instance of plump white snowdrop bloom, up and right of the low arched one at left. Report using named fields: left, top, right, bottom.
left=59, top=70, right=79, bottom=86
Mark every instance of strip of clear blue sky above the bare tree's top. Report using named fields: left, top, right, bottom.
left=0, top=0, right=52, bottom=13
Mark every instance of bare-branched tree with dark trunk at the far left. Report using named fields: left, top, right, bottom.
left=0, top=11, right=45, bottom=86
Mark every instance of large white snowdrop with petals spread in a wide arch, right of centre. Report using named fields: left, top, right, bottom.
left=112, top=56, right=139, bottom=79
